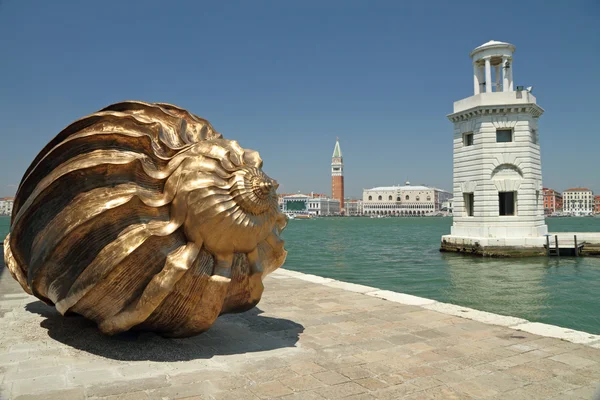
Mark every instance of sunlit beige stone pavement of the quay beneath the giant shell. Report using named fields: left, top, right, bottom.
left=0, top=264, right=600, bottom=400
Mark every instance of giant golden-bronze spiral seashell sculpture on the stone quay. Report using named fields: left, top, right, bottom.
left=4, top=101, right=287, bottom=337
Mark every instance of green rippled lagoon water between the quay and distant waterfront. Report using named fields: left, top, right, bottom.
left=0, top=217, right=600, bottom=334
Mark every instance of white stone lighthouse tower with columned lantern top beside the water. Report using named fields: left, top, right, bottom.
left=442, top=40, right=548, bottom=255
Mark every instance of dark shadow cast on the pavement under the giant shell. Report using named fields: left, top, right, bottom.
left=25, top=301, right=304, bottom=361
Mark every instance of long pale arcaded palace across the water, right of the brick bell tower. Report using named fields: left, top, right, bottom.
left=363, top=182, right=452, bottom=217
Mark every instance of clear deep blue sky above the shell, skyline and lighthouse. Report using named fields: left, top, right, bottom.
left=0, top=0, right=600, bottom=196
